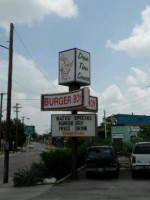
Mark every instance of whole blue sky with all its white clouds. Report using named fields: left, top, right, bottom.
left=0, top=0, right=150, bottom=134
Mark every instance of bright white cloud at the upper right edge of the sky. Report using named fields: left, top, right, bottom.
left=106, top=6, right=150, bottom=56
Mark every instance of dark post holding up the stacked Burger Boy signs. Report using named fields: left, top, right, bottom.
left=69, top=83, right=80, bottom=180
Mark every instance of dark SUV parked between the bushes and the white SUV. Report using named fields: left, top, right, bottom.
left=86, top=145, right=119, bottom=178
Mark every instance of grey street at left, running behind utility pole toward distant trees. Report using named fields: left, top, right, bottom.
left=0, top=142, right=44, bottom=183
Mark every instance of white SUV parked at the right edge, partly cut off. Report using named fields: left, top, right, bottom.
left=131, top=142, right=150, bottom=178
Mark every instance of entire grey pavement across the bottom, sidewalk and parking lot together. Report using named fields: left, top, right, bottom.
left=0, top=168, right=150, bottom=200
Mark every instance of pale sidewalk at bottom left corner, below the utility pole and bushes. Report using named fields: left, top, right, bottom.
left=0, top=181, right=52, bottom=200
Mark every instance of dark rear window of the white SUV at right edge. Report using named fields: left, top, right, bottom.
left=133, top=144, right=150, bottom=154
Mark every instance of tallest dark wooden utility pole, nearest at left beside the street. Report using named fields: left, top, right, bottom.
left=3, top=23, right=14, bottom=183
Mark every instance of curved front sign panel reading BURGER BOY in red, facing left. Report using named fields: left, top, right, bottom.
left=41, top=87, right=89, bottom=111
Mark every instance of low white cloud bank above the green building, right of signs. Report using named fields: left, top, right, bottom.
left=97, top=79, right=150, bottom=123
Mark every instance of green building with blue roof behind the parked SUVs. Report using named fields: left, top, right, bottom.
left=111, top=114, right=150, bottom=142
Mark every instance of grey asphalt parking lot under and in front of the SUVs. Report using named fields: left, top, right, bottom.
left=34, top=168, right=150, bottom=200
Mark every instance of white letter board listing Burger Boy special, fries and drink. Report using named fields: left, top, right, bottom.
left=51, top=114, right=97, bottom=137
